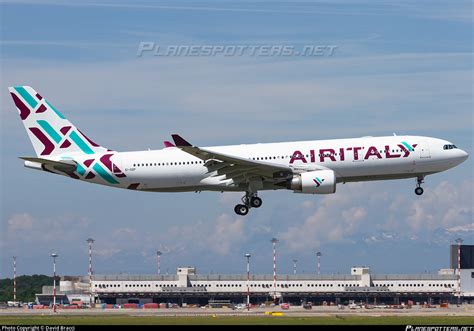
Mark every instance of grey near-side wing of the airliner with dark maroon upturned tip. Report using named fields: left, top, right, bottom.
left=172, top=134, right=293, bottom=184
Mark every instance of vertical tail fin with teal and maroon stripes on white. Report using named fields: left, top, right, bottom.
left=8, top=86, right=107, bottom=158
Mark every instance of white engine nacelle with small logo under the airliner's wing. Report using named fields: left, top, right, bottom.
left=288, top=170, right=336, bottom=194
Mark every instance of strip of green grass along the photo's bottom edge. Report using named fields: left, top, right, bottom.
left=0, top=315, right=474, bottom=325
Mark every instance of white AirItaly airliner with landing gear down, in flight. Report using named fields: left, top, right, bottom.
left=9, top=86, right=469, bottom=216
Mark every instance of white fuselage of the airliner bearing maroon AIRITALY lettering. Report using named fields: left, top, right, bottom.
left=74, top=136, right=468, bottom=192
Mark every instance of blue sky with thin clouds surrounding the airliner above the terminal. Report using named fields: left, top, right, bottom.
left=0, top=0, right=474, bottom=277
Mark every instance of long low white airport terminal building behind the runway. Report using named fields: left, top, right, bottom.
left=37, top=245, right=474, bottom=305
